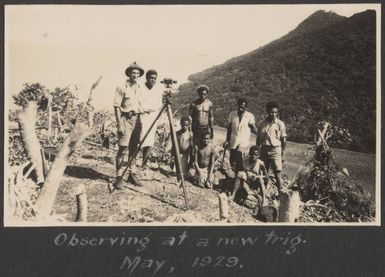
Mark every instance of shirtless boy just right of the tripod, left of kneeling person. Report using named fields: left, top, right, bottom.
left=173, top=117, right=193, bottom=181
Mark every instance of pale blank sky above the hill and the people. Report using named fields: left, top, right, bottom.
left=5, top=4, right=378, bottom=108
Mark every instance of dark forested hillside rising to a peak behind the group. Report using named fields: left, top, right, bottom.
left=174, top=10, right=376, bottom=152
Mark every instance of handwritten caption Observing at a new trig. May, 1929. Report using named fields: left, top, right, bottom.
left=53, top=230, right=307, bottom=275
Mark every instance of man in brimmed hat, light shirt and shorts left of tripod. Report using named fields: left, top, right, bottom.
left=114, top=62, right=144, bottom=189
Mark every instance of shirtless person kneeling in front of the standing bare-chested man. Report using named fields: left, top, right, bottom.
left=194, top=132, right=217, bottom=188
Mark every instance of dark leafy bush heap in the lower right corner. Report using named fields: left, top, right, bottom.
left=295, top=128, right=375, bottom=222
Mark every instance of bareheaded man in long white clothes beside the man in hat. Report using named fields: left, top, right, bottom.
left=139, top=69, right=164, bottom=167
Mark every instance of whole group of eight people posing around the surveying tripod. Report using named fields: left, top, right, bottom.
left=114, top=62, right=287, bottom=199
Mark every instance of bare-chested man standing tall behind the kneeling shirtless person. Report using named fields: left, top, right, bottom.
left=189, top=85, right=214, bottom=145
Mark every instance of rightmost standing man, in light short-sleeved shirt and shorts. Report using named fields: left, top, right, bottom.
left=257, top=101, right=287, bottom=193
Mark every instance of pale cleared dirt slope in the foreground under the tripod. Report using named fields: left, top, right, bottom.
left=54, top=143, right=258, bottom=224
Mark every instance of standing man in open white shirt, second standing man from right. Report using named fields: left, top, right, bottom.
left=223, top=98, right=257, bottom=173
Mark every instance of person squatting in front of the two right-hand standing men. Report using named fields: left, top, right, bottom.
left=230, top=145, right=269, bottom=206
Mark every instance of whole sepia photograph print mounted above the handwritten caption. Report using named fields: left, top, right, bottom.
left=3, top=4, right=381, bottom=227
